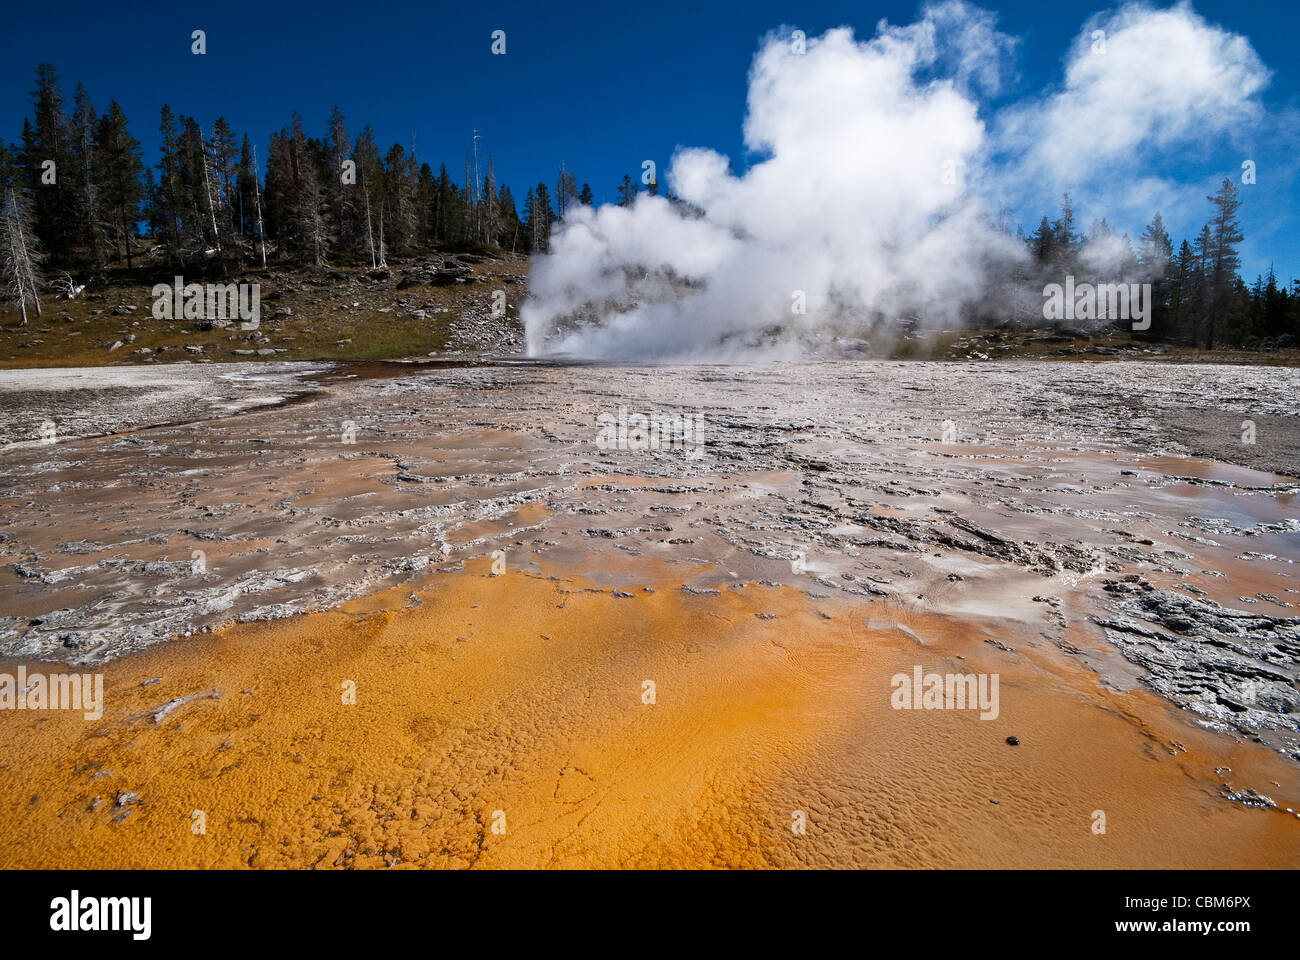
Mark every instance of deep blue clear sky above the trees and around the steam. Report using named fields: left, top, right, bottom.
left=0, top=0, right=1300, bottom=278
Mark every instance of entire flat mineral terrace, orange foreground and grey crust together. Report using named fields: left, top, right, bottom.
left=0, top=362, right=1300, bottom=866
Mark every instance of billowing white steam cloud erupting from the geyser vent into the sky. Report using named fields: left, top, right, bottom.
left=523, top=3, right=1268, bottom=359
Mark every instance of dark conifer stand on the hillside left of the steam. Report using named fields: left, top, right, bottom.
left=0, top=64, right=670, bottom=290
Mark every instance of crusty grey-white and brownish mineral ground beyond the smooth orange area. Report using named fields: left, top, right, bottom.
left=0, top=362, right=1300, bottom=749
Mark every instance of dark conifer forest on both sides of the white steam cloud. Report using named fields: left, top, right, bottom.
left=0, top=64, right=1300, bottom=350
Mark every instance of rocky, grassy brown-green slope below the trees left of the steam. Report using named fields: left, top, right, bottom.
left=0, top=254, right=528, bottom=368
